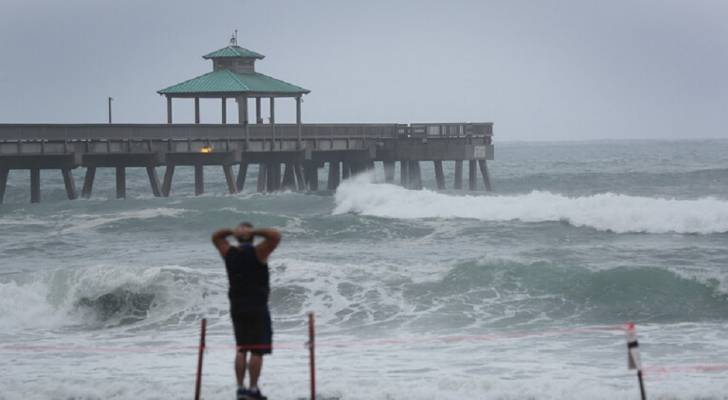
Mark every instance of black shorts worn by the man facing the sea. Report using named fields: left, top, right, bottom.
left=230, top=307, right=273, bottom=355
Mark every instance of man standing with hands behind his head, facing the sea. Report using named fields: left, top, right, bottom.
left=212, top=222, right=281, bottom=400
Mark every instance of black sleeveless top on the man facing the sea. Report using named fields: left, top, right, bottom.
left=225, top=244, right=270, bottom=307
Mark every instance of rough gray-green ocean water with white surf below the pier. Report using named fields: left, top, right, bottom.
left=0, top=141, right=728, bottom=400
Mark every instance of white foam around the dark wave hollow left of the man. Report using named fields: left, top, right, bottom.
left=0, top=265, right=219, bottom=333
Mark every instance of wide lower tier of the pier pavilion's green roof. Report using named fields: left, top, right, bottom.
left=157, top=69, right=310, bottom=96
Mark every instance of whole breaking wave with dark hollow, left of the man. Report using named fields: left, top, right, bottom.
left=0, top=266, right=224, bottom=331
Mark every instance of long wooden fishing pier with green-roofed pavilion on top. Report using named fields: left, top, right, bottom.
left=0, top=37, right=493, bottom=203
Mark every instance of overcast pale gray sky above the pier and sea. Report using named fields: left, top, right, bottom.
left=0, top=0, right=728, bottom=141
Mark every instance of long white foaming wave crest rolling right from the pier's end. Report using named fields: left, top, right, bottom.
left=334, top=174, right=728, bottom=234
